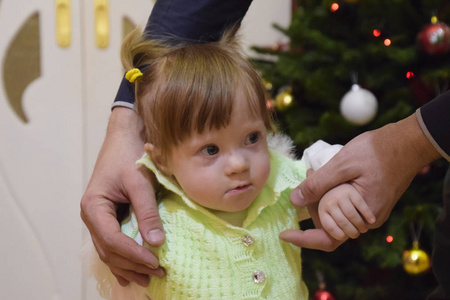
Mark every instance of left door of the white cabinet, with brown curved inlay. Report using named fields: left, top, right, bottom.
left=0, top=0, right=83, bottom=300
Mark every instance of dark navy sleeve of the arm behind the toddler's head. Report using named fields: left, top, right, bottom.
left=113, top=0, right=252, bottom=107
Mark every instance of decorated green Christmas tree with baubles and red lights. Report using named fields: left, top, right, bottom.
left=255, top=0, right=450, bottom=300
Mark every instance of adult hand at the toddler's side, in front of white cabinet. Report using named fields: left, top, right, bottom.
left=80, top=107, right=165, bottom=286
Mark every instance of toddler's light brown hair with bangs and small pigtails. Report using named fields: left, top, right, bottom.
left=121, top=29, right=273, bottom=157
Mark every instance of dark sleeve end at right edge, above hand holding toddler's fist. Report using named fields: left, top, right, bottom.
left=417, top=91, right=450, bottom=161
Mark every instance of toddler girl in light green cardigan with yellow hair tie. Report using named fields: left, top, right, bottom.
left=87, top=30, right=373, bottom=300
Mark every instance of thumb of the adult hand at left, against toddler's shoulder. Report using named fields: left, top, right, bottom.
left=129, top=167, right=165, bottom=247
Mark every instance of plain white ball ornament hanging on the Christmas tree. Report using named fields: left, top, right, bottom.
left=340, top=84, right=378, bottom=125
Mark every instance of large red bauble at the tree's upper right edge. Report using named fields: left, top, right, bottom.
left=417, top=22, right=450, bottom=54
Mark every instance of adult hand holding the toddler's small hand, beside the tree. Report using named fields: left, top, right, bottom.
left=280, top=114, right=440, bottom=251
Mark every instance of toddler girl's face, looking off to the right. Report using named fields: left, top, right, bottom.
left=167, top=99, right=270, bottom=212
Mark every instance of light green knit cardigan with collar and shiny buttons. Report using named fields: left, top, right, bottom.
left=122, top=151, right=309, bottom=300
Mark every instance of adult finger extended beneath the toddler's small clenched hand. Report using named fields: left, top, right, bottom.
left=280, top=229, right=344, bottom=252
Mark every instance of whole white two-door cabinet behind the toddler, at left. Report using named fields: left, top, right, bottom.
left=0, top=0, right=153, bottom=300
